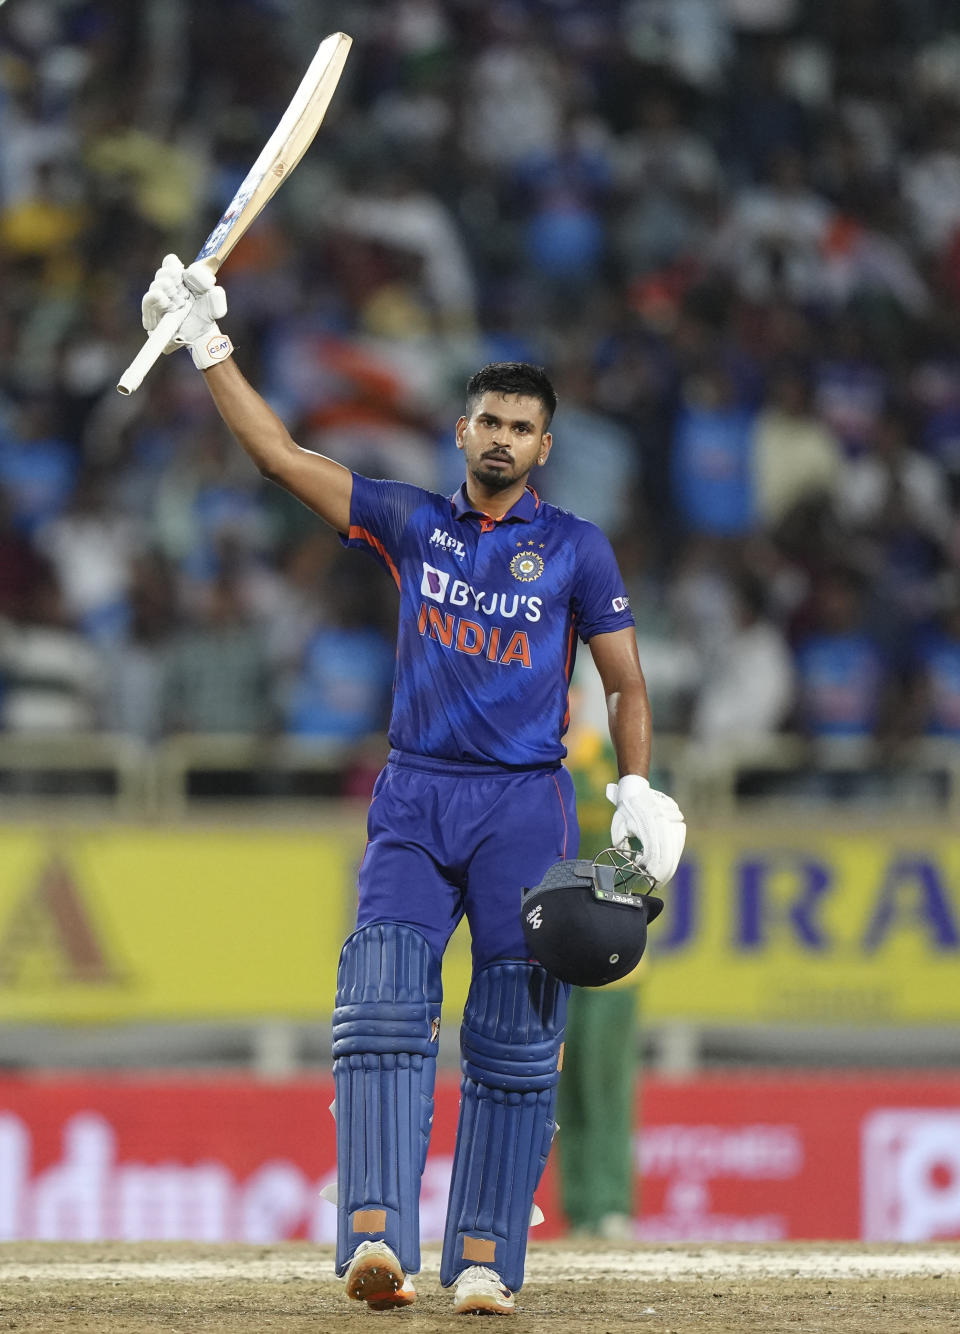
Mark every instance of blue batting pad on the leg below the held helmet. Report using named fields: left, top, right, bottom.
left=440, top=960, right=569, bottom=1291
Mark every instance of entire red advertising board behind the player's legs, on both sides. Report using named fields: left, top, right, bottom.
left=0, top=1075, right=960, bottom=1243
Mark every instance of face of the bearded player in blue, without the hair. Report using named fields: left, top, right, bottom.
left=456, top=392, right=552, bottom=491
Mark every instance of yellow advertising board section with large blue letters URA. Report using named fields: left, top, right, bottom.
left=644, top=826, right=960, bottom=1026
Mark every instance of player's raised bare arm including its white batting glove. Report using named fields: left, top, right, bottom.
left=143, top=255, right=353, bottom=532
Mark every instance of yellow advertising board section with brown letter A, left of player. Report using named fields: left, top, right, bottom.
left=0, top=824, right=363, bottom=1023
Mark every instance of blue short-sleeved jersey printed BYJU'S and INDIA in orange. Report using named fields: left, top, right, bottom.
left=343, top=475, right=633, bottom=768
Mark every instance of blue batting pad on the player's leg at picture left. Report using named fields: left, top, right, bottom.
left=333, top=922, right=441, bottom=1274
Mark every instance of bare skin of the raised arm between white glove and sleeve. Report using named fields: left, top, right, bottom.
left=204, top=358, right=353, bottom=532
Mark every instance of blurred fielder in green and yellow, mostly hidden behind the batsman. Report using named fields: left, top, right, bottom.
left=556, top=730, right=645, bottom=1241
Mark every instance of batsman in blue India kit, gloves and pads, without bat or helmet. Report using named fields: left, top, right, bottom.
left=143, top=256, right=685, bottom=1314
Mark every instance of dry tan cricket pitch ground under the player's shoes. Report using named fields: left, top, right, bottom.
left=0, top=1242, right=960, bottom=1334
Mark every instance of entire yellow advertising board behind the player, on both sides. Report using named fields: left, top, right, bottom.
left=0, top=818, right=960, bottom=1025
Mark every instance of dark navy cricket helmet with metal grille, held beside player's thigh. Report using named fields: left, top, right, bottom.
left=520, top=848, right=663, bottom=987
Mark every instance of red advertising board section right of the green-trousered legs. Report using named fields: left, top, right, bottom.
left=636, top=1074, right=960, bottom=1241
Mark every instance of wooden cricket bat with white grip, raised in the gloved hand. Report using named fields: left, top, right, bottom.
left=117, top=32, right=353, bottom=394
